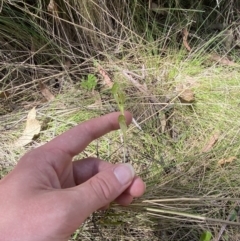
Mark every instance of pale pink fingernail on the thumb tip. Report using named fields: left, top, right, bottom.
left=114, top=163, right=135, bottom=185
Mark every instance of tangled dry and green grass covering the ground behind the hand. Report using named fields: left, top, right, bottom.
left=0, top=0, right=240, bottom=241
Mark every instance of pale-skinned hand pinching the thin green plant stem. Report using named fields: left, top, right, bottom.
left=0, top=112, right=145, bottom=241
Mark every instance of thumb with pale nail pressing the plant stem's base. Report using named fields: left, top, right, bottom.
left=69, top=164, right=135, bottom=222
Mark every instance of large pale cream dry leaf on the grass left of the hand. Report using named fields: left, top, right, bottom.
left=14, top=107, right=41, bottom=147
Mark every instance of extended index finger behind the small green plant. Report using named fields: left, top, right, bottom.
left=44, top=112, right=132, bottom=157
